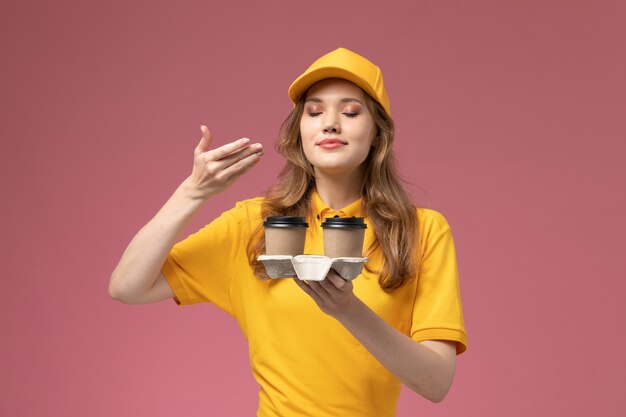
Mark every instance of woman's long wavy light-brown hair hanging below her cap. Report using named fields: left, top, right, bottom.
left=247, top=88, right=418, bottom=291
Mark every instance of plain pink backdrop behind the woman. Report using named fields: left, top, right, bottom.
left=0, top=0, right=626, bottom=417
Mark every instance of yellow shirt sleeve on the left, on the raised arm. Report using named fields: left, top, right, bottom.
left=161, top=200, right=254, bottom=315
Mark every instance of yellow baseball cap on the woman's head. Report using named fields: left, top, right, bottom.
left=289, top=48, right=391, bottom=115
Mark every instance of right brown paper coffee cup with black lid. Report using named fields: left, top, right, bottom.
left=322, top=216, right=367, bottom=258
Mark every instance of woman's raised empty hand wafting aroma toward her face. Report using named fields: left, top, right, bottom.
left=187, top=126, right=263, bottom=200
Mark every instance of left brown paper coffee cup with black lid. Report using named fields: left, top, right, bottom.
left=263, top=216, right=309, bottom=256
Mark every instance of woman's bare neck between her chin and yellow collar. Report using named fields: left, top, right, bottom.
left=315, top=170, right=363, bottom=210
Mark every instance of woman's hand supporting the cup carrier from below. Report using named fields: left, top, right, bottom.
left=294, top=269, right=356, bottom=317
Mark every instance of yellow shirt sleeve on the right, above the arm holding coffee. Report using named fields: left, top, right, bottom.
left=411, top=209, right=467, bottom=354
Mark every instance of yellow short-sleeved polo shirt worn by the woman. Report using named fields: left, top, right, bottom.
left=163, top=194, right=467, bottom=417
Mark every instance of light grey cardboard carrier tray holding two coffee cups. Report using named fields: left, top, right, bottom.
left=259, top=255, right=367, bottom=281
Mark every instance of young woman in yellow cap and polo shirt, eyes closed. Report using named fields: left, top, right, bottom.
left=109, top=48, right=467, bottom=417
